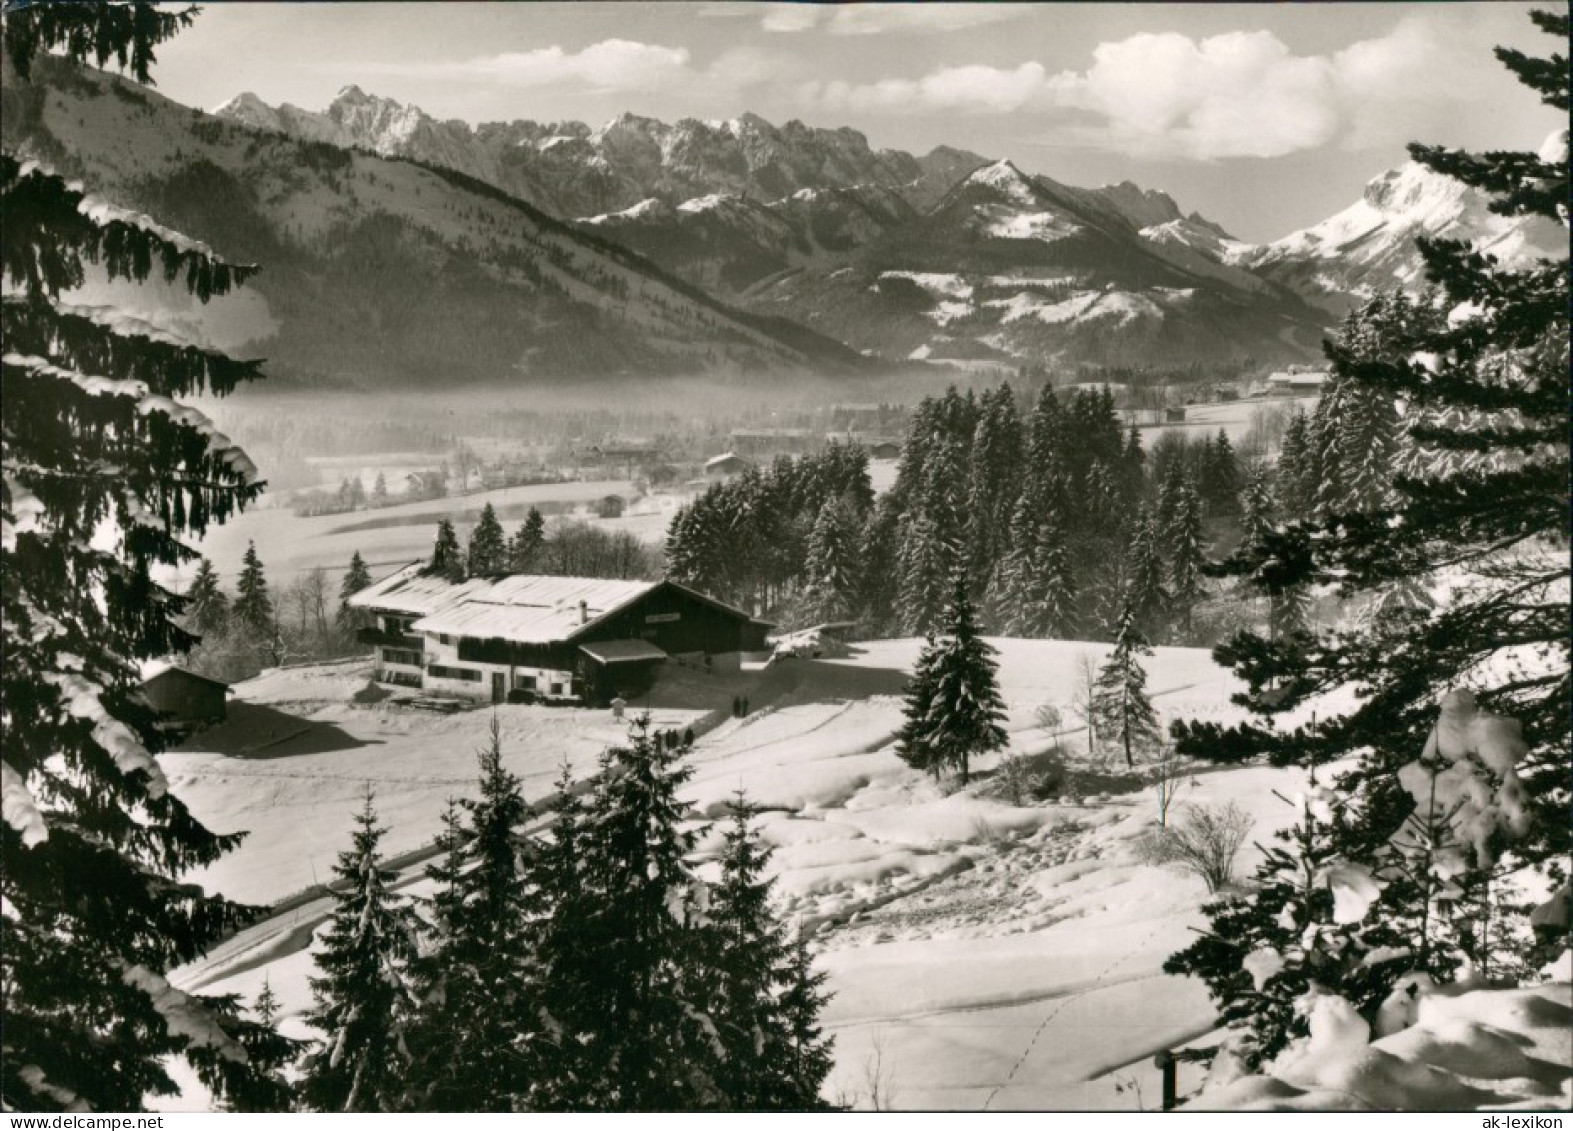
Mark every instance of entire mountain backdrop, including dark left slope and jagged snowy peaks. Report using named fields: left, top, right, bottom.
left=15, top=68, right=1565, bottom=381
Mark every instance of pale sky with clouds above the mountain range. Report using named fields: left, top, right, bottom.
left=154, top=2, right=1565, bottom=241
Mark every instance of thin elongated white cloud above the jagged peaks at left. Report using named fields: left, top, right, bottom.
left=362, top=39, right=692, bottom=91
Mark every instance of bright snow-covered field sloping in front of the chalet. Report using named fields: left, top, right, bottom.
left=164, top=640, right=1459, bottom=1109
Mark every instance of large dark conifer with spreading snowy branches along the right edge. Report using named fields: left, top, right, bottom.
left=1181, top=13, right=1573, bottom=1025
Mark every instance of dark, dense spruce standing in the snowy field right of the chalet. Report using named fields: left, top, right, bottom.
left=897, top=571, right=1007, bottom=785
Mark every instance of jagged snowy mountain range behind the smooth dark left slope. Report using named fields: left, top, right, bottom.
left=216, top=87, right=1560, bottom=371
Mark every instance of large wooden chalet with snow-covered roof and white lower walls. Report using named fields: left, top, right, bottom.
left=349, top=562, right=771, bottom=703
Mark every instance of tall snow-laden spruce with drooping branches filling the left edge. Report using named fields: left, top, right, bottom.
left=0, top=3, right=291, bottom=1112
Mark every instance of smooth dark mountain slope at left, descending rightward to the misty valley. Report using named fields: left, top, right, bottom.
left=3, top=60, right=867, bottom=387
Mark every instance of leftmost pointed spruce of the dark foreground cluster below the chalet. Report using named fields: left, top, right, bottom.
left=300, top=790, right=415, bottom=1112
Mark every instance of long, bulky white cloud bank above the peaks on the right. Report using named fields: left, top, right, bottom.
left=798, top=21, right=1494, bottom=160
